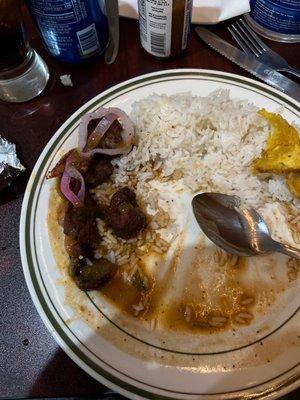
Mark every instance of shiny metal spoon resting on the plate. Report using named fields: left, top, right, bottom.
left=192, top=193, right=300, bottom=259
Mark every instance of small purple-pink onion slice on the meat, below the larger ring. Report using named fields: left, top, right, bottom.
left=60, top=160, right=85, bottom=207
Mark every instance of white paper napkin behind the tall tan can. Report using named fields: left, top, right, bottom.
left=119, top=0, right=250, bottom=24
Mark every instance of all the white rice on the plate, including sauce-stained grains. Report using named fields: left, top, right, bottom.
left=92, top=91, right=300, bottom=280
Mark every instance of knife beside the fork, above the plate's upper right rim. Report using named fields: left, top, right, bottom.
left=195, top=26, right=300, bottom=101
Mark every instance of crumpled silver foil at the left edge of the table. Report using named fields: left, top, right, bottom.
left=0, top=136, right=25, bottom=190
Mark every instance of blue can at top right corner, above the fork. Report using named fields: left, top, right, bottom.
left=246, top=0, right=300, bottom=42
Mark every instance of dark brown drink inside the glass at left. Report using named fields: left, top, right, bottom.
left=0, top=21, right=28, bottom=72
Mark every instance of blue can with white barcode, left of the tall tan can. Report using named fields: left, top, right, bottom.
left=26, top=0, right=109, bottom=63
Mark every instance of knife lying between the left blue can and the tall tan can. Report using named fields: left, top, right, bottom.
left=104, top=0, right=119, bottom=64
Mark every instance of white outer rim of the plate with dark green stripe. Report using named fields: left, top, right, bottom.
left=19, top=68, right=300, bottom=399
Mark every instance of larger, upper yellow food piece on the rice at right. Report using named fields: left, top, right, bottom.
left=252, top=109, right=300, bottom=174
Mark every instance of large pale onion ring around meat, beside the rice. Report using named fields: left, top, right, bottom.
left=78, top=107, right=134, bottom=156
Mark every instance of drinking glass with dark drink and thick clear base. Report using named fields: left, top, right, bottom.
left=0, top=0, right=49, bottom=103
